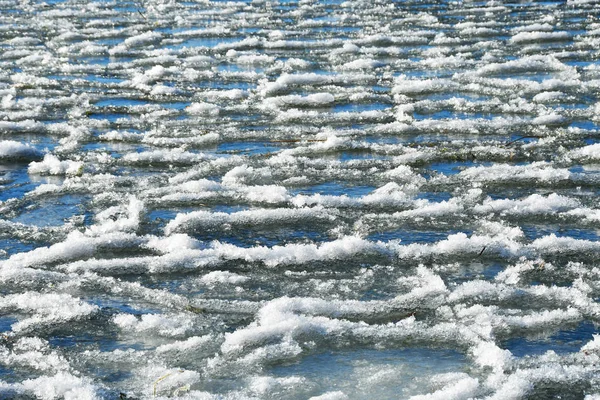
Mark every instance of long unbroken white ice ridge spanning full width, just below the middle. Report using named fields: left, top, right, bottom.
left=0, top=214, right=600, bottom=280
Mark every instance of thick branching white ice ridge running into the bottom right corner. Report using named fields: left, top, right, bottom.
left=207, top=269, right=597, bottom=398
